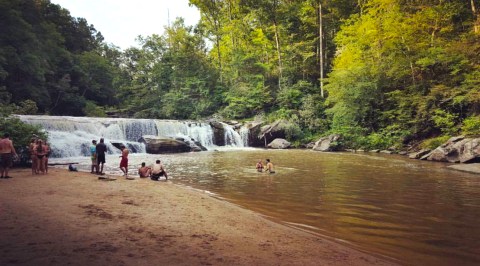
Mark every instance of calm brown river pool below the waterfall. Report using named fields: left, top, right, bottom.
left=54, top=149, right=480, bottom=265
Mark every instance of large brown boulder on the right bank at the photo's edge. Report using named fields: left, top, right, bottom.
left=421, top=137, right=480, bottom=163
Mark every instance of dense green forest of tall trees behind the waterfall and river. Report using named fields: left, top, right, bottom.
left=0, top=0, right=480, bottom=149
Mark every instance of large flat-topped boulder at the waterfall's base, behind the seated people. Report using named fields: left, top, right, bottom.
left=140, top=135, right=192, bottom=154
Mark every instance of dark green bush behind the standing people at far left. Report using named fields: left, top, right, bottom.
left=0, top=117, right=48, bottom=165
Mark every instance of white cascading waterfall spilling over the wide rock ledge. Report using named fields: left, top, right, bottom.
left=18, top=116, right=245, bottom=158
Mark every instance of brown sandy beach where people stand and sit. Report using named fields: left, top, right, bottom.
left=0, top=168, right=395, bottom=265
